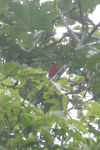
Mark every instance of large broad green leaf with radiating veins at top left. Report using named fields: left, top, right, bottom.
left=8, top=0, right=57, bottom=31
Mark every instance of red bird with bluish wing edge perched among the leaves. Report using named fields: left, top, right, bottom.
left=49, top=62, right=60, bottom=78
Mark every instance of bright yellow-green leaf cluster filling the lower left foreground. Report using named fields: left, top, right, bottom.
left=0, top=62, right=85, bottom=149
